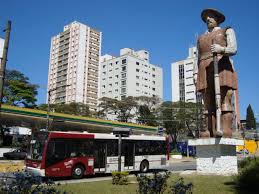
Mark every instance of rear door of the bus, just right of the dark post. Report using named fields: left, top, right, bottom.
left=122, top=141, right=135, bottom=170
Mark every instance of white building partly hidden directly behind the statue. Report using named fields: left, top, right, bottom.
left=171, top=47, right=197, bottom=102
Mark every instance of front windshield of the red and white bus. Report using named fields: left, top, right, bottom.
left=28, top=132, right=48, bottom=160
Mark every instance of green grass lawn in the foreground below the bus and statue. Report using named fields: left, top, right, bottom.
left=58, top=174, right=238, bottom=194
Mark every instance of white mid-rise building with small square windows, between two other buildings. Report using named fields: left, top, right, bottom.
left=100, top=48, right=163, bottom=100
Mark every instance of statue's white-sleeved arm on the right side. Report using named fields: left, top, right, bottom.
left=224, top=28, right=237, bottom=56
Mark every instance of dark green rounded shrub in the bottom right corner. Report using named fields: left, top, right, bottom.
left=235, top=157, right=259, bottom=192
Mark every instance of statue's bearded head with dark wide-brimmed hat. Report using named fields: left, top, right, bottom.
left=201, top=9, right=225, bottom=30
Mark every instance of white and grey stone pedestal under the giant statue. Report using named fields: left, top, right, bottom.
left=188, top=138, right=244, bottom=175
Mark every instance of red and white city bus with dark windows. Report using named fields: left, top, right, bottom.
left=25, top=131, right=169, bottom=178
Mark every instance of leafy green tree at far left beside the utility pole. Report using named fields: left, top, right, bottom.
left=3, top=70, right=38, bottom=108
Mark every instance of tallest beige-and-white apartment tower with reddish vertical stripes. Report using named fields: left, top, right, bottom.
left=47, top=21, right=102, bottom=110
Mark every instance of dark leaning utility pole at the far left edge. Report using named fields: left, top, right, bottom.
left=0, top=21, right=11, bottom=142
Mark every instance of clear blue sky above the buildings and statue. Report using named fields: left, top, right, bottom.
left=0, top=0, right=259, bottom=120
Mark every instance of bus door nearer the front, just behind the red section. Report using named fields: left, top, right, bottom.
left=94, top=140, right=107, bottom=172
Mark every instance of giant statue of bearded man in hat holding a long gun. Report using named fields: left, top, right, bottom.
left=194, top=9, right=237, bottom=137
